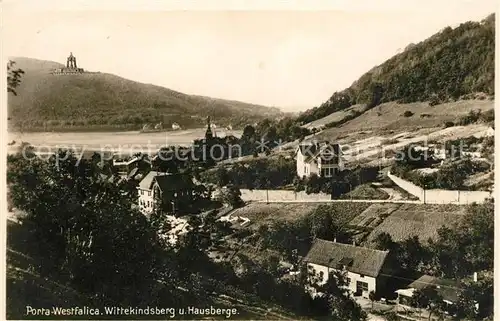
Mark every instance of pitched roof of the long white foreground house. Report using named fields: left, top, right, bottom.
left=305, top=239, right=389, bottom=277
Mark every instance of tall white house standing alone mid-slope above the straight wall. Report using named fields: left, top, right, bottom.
left=295, top=142, right=344, bottom=177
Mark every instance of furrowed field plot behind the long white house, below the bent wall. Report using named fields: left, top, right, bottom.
left=367, top=204, right=466, bottom=245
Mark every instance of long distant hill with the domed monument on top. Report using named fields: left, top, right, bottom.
left=8, top=57, right=282, bottom=131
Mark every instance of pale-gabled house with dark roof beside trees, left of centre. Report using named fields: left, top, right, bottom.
left=137, top=171, right=195, bottom=215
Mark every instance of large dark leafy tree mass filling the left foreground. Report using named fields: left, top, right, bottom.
left=8, top=151, right=176, bottom=304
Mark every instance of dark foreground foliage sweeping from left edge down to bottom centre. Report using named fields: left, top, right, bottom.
left=8, top=151, right=370, bottom=321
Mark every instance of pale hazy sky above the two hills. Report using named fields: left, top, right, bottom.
left=2, top=0, right=496, bottom=110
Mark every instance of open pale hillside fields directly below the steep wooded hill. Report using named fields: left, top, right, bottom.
left=280, top=100, right=494, bottom=166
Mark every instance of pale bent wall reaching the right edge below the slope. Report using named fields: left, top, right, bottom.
left=387, top=172, right=493, bottom=205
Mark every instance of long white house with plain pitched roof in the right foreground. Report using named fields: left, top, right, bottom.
left=304, top=239, right=391, bottom=298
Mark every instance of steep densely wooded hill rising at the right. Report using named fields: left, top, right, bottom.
left=298, top=14, right=495, bottom=123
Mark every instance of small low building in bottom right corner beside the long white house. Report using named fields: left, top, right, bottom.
left=396, top=275, right=460, bottom=309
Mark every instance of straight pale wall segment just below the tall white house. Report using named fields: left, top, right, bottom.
left=240, top=189, right=332, bottom=202
